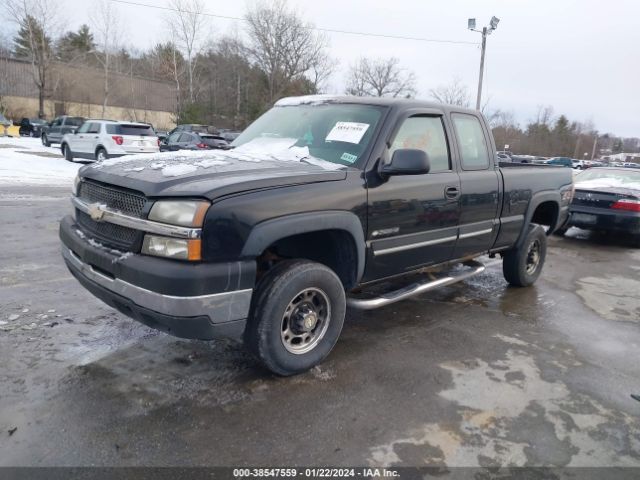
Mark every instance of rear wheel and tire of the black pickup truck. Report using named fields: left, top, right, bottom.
left=502, top=224, right=547, bottom=287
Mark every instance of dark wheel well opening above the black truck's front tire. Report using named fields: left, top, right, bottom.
left=258, top=230, right=358, bottom=290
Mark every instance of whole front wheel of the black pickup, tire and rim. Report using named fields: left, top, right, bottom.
left=245, top=260, right=346, bottom=376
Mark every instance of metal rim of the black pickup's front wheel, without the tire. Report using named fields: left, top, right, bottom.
left=280, top=288, right=331, bottom=355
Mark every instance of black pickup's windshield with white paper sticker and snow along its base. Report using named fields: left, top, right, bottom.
left=232, top=104, right=385, bottom=166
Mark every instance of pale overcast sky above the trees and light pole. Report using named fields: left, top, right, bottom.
left=5, top=0, right=640, bottom=137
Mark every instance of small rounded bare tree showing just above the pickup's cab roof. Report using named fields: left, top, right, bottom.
left=346, top=57, right=416, bottom=97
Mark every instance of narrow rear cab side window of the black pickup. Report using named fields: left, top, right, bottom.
left=451, top=113, right=489, bottom=170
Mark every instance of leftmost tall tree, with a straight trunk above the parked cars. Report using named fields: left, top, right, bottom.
left=5, top=0, right=59, bottom=118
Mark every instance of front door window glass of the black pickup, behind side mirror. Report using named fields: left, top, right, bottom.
left=388, top=116, right=451, bottom=173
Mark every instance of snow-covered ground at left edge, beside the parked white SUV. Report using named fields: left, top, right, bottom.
left=0, top=137, right=82, bottom=187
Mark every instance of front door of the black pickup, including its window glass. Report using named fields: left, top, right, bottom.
left=364, top=113, right=460, bottom=281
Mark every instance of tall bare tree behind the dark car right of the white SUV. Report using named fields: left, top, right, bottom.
left=167, top=0, right=206, bottom=103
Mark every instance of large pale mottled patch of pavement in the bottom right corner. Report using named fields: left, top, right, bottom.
left=369, top=335, right=640, bottom=467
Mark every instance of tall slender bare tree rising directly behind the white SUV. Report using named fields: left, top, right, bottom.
left=89, top=0, right=121, bottom=117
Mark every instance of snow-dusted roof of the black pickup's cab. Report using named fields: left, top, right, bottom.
left=275, top=95, right=478, bottom=114
